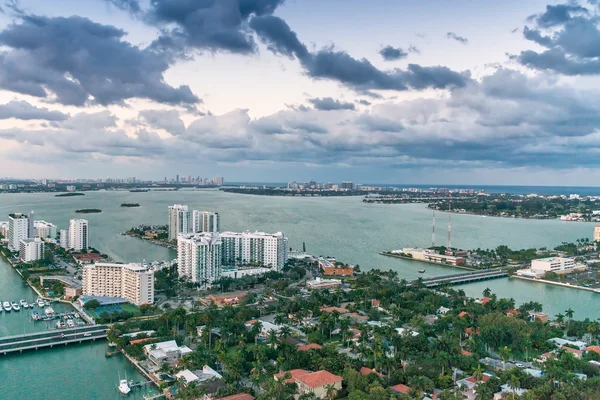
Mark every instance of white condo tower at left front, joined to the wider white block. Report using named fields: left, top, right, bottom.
left=177, top=232, right=221, bottom=284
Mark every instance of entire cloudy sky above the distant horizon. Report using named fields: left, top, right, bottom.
left=0, top=0, right=600, bottom=185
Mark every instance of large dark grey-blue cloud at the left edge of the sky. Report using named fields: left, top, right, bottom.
left=0, top=14, right=199, bottom=106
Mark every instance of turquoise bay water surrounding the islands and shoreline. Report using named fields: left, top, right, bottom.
left=0, top=190, right=600, bottom=400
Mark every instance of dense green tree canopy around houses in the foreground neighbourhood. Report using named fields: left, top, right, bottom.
left=109, top=266, right=600, bottom=400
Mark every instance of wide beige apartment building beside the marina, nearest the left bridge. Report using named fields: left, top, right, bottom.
left=82, top=263, right=154, bottom=306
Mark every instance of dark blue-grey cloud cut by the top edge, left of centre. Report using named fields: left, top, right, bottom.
left=145, top=0, right=283, bottom=54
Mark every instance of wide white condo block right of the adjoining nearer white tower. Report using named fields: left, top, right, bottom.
left=219, top=232, right=287, bottom=269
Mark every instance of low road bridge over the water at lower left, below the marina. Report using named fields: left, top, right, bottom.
left=0, top=325, right=108, bottom=355
